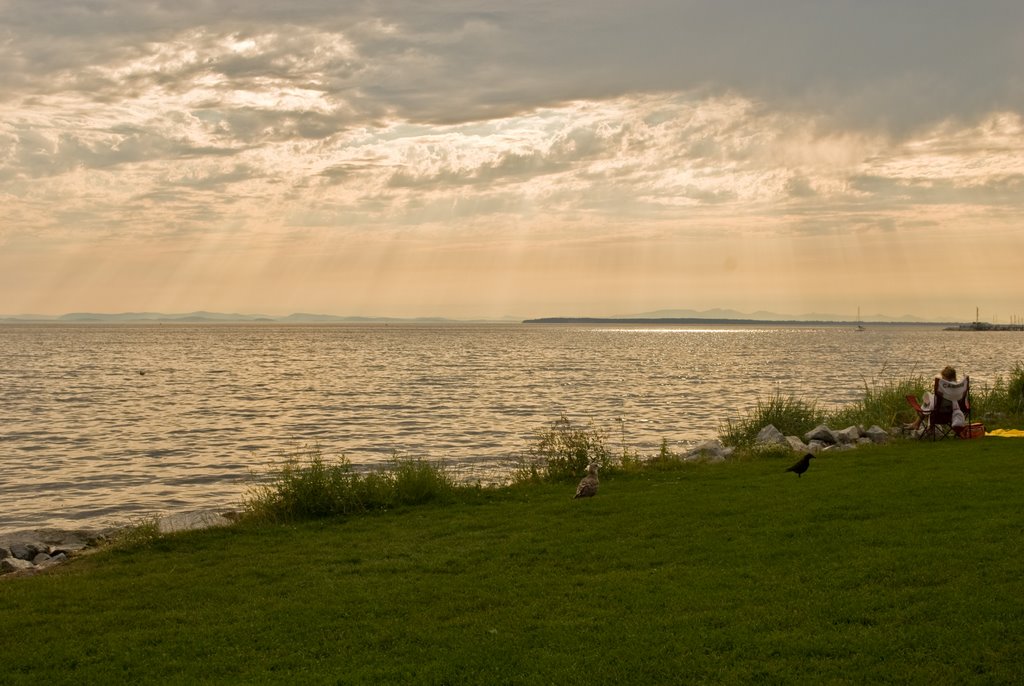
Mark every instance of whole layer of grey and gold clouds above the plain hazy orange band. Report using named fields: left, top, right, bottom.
left=0, top=0, right=1024, bottom=317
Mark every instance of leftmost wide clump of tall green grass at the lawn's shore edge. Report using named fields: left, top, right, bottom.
left=243, top=447, right=459, bottom=521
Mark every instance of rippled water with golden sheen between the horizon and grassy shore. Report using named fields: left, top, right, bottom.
left=0, top=325, right=1024, bottom=531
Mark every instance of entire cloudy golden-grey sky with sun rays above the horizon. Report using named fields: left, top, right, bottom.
left=0, top=0, right=1024, bottom=321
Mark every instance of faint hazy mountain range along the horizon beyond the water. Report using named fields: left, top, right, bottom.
left=0, top=309, right=952, bottom=324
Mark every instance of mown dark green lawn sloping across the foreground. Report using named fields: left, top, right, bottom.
left=0, top=438, right=1024, bottom=684
